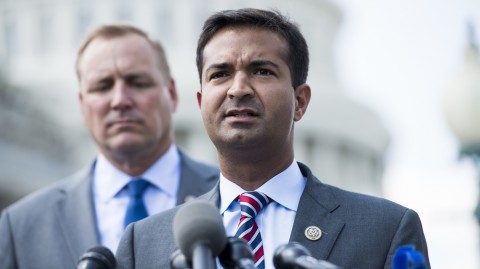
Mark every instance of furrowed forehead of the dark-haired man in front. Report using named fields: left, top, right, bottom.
left=203, top=27, right=288, bottom=69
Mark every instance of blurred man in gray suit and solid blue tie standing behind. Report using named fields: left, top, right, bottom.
left=0, top=25, right=218, bottom=269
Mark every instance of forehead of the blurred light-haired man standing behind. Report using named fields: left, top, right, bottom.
left=79, top=34, right=157, bottom=77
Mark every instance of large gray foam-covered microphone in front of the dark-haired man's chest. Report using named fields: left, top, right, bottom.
left=173, top=200, right=227, bottom=269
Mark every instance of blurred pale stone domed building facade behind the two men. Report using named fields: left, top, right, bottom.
left=0, top=0, right=389, bottom=208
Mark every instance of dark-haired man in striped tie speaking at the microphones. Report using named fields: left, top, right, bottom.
left=117, top=9, right=428, bottom=269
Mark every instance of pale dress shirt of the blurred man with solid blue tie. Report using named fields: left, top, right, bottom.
left=93, top=145, right=181, bottom=250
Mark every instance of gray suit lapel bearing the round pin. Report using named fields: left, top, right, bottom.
left=290, top=163, right=345, bottom=260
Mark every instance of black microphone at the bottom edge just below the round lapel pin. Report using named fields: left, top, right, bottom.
left=273, top=242, right=341, bottom=269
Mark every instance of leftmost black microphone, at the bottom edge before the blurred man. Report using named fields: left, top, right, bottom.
left=77, top=246, right=117, bottom=269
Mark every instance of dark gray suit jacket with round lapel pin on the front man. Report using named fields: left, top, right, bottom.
left=116, top=163, right=430, bottom=269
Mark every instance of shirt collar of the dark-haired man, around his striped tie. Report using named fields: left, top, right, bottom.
left=220, top=160, right=306, bottom=214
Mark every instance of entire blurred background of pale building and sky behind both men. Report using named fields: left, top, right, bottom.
left=0, top=0, right=480, bottom=269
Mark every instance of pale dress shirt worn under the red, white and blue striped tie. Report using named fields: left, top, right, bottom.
left=220, top=160, right=306, bottom=269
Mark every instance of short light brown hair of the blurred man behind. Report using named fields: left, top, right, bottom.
left=75, top=23, right=171, bottom=80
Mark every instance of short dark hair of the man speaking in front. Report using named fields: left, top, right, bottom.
left=196, top=8, right=309, bottom=89
